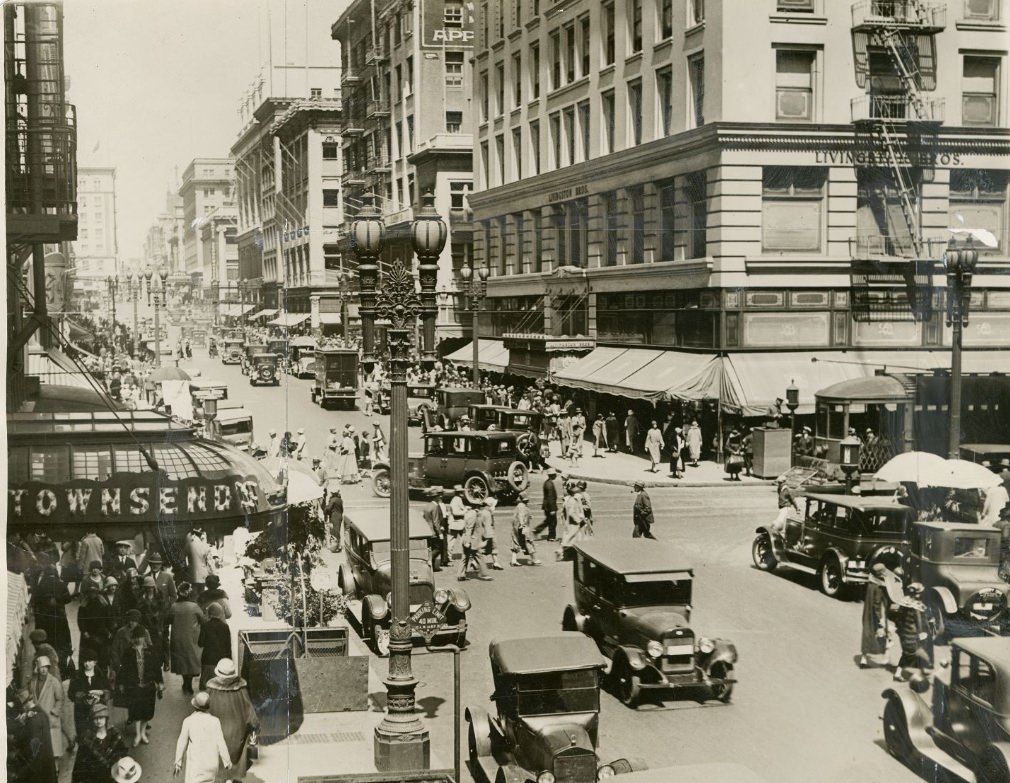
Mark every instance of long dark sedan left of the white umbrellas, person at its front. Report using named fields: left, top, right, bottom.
left=751, top=494, right=912, bottom=598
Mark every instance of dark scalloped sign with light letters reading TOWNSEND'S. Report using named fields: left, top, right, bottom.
left=7, top=473, right=273, bottom=524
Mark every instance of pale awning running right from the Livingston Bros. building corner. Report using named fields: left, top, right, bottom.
left=719, top=351, right=1010, bottom=416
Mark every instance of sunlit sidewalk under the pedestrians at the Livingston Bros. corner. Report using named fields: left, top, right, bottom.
left=547, top=441, right=775, bottom=487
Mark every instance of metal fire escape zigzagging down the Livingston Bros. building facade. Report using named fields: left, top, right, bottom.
left=851, top=0, right=946, bottom=320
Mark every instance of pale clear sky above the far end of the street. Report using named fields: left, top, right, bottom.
left=64, top=0, right=343, bottom=262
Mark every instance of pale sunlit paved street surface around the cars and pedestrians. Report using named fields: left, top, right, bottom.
left=132, top=355, right=916, bottom=782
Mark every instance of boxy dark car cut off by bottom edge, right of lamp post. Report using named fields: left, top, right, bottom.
left=466, top=633, right=645, bottom=783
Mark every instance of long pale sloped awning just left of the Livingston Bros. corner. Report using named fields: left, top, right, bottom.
left=554, top=347, right=719, bottom=402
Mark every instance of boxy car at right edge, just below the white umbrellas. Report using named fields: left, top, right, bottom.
left=904, top=522, right=1010, bottom=639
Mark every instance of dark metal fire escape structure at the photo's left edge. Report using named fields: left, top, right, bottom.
left=3, top=3, right=77, bottom=410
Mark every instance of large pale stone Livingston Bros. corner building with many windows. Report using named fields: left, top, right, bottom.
left=470, top=0, right=1010, bottom=414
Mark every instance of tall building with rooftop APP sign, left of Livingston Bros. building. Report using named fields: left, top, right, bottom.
left=332, top=0, right=474, bottom=340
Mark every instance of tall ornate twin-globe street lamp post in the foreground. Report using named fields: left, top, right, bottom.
left=350, top=193, right=447, bottom=772
